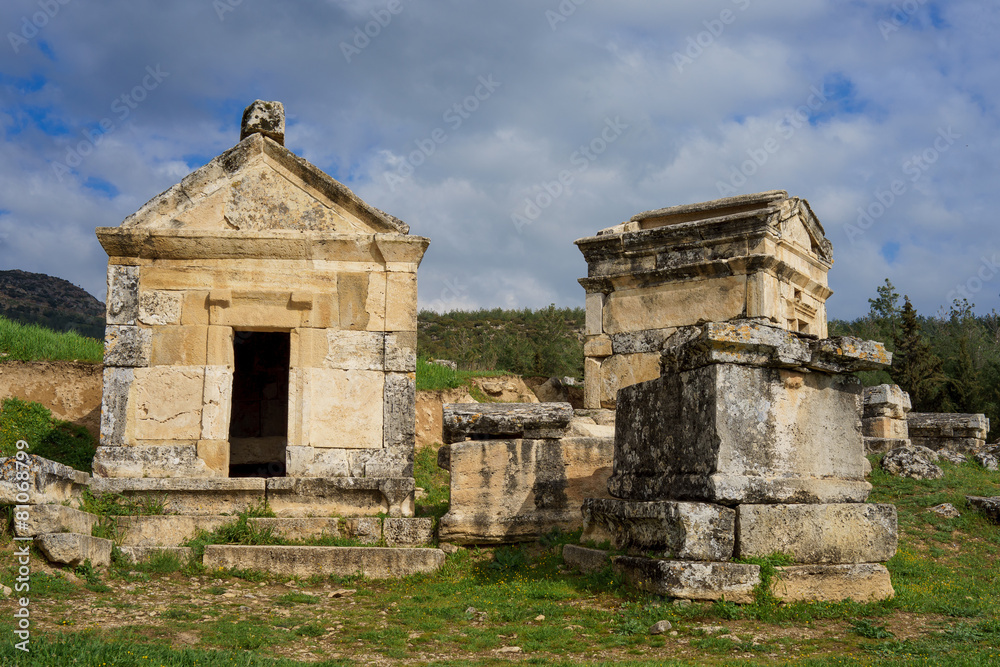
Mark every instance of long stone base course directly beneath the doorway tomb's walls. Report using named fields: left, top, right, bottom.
left=90, top=477, right=416, bottom=517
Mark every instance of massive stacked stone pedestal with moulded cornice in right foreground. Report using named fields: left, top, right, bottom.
left=583, top=320, right=896, bottom=602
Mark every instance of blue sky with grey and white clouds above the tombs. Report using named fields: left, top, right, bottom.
left=0, top=0, right=1000, bottom=317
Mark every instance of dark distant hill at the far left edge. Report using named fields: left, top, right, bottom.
left=0, top=270, right=104, bottom=339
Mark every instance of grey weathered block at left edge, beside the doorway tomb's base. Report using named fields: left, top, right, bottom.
left=0, top=454, right=90, bottom=505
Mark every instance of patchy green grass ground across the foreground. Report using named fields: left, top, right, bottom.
left=0, top=450, right=1000, bottom=667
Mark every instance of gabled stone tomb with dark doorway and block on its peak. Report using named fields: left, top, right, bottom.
left=94, top=102, right=429, bottom=516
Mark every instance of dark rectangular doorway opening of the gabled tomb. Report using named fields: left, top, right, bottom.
left=229, top=331, right=291, bottom=477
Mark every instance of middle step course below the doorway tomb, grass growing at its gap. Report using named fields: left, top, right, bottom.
left=113, top=514, right=434, bottom=547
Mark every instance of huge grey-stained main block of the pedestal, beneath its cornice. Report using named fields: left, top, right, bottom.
left=608, top=364, right=871, bottom=505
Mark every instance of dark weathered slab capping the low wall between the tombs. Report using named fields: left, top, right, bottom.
left=443, top=403, right=573, bottom=445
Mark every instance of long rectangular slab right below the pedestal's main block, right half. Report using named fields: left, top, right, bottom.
left=736, top=503, right=897, bottom=564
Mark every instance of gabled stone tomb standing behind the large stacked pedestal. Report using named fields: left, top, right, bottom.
left=576, top=191, right=833, bottom=408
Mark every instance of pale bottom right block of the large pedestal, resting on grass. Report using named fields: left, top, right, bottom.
left=771, top=563, right=896, bottom=603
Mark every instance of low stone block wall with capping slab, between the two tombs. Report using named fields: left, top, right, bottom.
left=438, top=403, right=614, bottom=544
